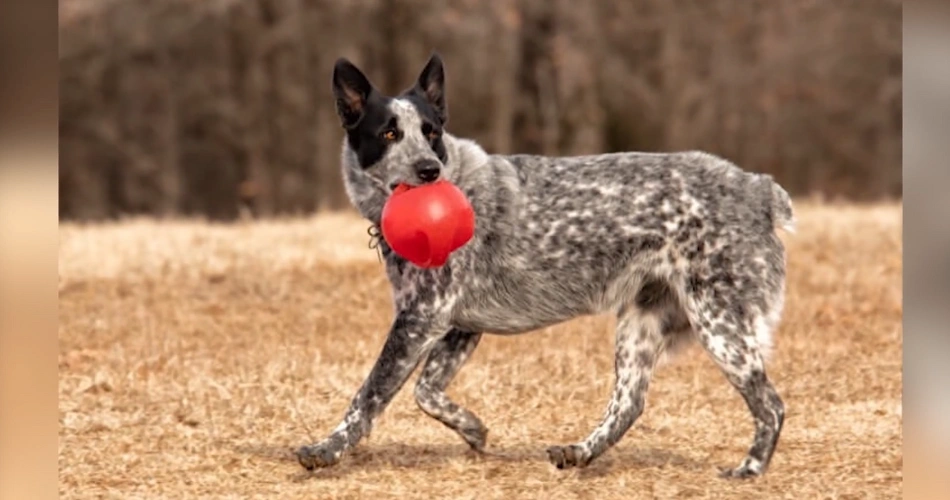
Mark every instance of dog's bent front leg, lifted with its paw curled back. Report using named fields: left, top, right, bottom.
left=415, top=329, right=488, bottom=451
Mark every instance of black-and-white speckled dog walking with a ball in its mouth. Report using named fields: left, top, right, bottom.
left=297, top=55, right=794, bottom=477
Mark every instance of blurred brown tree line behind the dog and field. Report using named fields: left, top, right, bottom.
left=60, top=0, right=902, bottom=220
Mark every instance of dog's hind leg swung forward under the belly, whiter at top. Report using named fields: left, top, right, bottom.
left=547, top=297, right=664, bottom=469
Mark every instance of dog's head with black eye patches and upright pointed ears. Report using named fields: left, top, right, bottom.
left=333, top=54, right=451, bottom=221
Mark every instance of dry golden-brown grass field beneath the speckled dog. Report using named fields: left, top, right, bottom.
left=59, top=202, right=903, bottom=500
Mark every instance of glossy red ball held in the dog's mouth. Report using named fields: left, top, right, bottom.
left=381, top=181, right=475, bottom=267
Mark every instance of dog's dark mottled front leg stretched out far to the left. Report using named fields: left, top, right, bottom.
left=297, top=311, right=446, bottom=470
